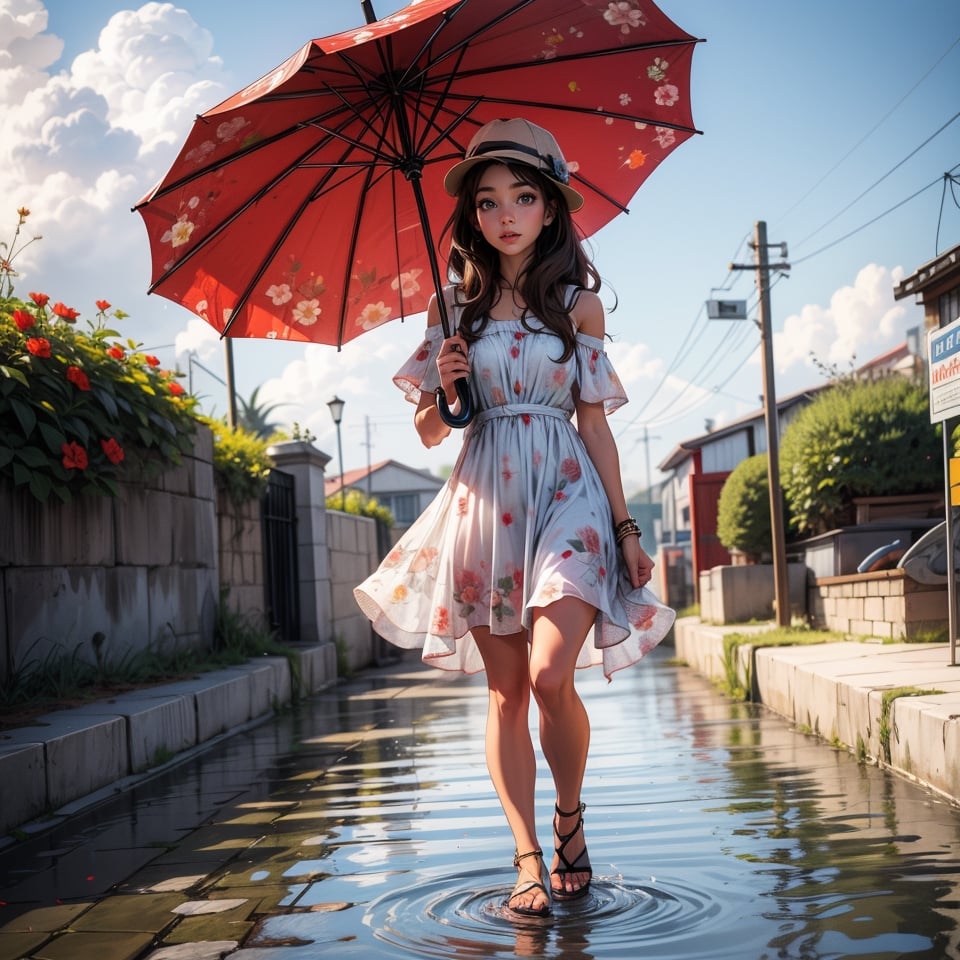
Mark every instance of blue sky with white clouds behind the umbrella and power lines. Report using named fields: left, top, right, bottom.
left=0, top=0, right=960, bottom=490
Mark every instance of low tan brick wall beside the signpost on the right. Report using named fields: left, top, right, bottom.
left=808, top=570, right=947, bottom=640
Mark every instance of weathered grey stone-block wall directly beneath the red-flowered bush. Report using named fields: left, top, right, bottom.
left=0, top=427, right=219, bottom=678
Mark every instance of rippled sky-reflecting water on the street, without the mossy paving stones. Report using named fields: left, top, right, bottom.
left=227, top=658, right=960, bottom=960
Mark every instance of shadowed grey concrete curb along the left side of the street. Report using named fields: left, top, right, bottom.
left=0, top=643, right=337, bottom=834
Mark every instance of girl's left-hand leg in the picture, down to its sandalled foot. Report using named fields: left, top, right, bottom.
left=473, top=628, right=549, bottom=910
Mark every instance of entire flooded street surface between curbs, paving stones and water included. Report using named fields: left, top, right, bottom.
left=0, top=649, right=960, bottom=960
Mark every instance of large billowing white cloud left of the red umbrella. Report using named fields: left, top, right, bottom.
left=0, top=0, right=226, bottom=316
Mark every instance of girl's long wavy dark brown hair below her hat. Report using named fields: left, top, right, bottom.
left=443, top=160, right=600, bottom=363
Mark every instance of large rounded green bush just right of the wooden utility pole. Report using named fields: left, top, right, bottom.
left=780, top=376, right=943, bottom=535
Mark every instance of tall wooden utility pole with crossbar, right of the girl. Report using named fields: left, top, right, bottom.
left=730, top=220, right=790, bottom=627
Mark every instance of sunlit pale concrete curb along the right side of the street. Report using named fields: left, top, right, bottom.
left=674, top=617, right=960, bottom=804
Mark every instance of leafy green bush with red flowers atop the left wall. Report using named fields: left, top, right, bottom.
left=0, top=293, right=196, bottom=503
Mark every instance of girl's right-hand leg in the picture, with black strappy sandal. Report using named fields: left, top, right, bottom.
left=530, top=597, right=596, bottom=894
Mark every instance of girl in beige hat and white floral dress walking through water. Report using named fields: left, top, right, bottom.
left=355, top=119, right=674, bottom=916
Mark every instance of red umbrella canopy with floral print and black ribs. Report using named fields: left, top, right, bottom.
left=135, top=0, right=698, bottom=346
